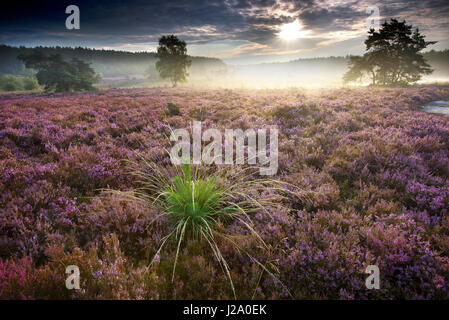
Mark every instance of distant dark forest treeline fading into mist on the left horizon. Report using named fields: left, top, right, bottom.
left=0, top=45, right=226, bottom=78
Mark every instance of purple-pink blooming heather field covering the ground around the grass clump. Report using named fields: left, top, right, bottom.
left=0, top=86, right=449, bottom=299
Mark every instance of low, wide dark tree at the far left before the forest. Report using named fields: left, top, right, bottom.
left=17, top=49, right=100, bottom=92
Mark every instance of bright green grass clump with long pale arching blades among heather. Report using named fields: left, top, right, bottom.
left=118, top=160, right=294, bottom=297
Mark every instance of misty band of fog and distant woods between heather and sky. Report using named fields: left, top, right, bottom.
left=0, top=46, right=449, bottom=88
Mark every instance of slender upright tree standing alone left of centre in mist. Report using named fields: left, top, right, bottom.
left=156, top=35, right=192, bottom=87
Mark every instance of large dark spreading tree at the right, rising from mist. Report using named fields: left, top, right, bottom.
left=343, top=19, right=436, bottom=86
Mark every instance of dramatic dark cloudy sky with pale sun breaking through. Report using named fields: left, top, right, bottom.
left=0, top=0, right=449, bottom=65
